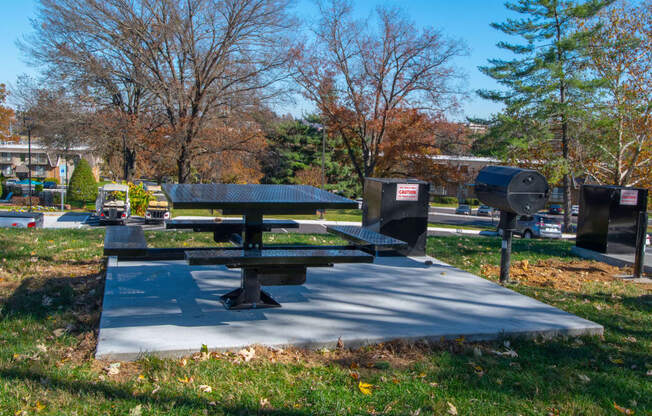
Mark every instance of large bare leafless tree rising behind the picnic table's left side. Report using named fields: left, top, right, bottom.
left=23, top=0, right=294, bottom=182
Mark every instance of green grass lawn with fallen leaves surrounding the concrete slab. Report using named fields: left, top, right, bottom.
left=0, top=229, right=652, bottom=415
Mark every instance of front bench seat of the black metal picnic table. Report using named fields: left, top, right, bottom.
left=186, top=248, right=374, bottom=267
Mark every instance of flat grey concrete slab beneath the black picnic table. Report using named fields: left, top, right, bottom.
left=96, top=257, right=603, bottom=360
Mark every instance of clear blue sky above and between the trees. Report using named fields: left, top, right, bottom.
left=0, top=0, right=508, bottom=118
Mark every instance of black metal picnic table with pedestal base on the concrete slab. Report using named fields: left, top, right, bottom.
left=163, top=184, right=392, bottom=309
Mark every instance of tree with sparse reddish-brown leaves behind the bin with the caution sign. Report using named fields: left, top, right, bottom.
left=294, top=0, right=465, bottom=182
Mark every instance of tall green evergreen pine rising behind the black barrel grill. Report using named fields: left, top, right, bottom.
left=477, top=0, right=613, bottom=229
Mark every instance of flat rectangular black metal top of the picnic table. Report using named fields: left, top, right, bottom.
left=163, top=183, right=358, bottom=214
